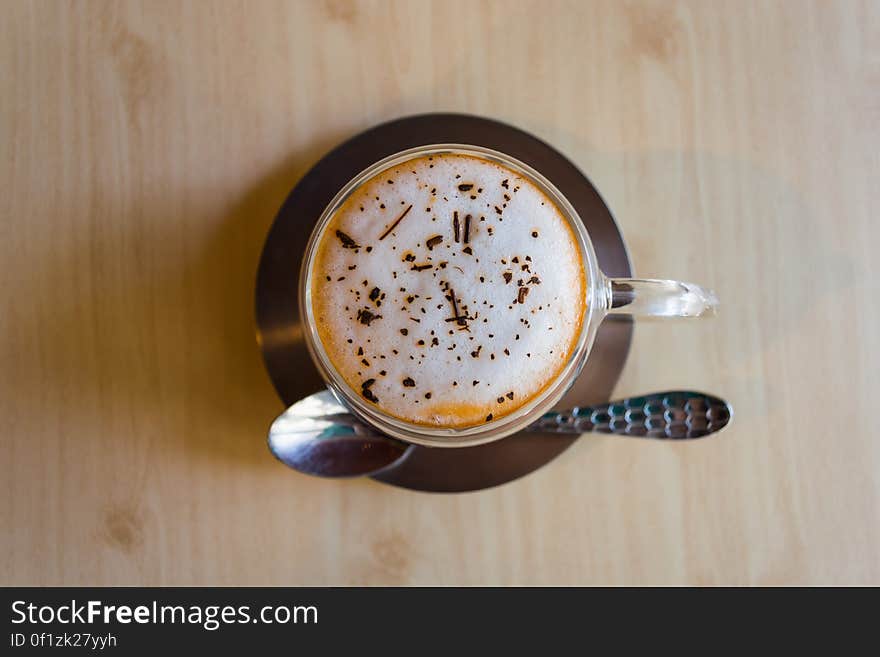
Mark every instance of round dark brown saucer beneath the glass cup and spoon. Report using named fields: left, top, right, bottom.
left=256, top=114, right=633, bottom=492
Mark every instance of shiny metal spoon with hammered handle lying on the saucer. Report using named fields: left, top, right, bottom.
left=269, top=390, right=733, bottom=477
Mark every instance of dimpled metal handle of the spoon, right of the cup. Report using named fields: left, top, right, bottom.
left=527, top=390, right=733, bottom=439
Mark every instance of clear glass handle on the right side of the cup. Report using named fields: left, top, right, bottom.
left=605, top=278, right=718, bottom=317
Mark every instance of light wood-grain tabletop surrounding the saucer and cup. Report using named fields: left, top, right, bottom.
left=0, top=0, right=880, bottom=585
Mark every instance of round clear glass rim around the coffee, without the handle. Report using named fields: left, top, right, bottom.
left=298, top=143, right=604, bottom=447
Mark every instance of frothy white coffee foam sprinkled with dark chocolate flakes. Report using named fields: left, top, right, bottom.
left=311, top=154, right=587, bottom=427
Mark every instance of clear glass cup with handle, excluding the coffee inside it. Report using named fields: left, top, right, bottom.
left=299, top=144, right=717, bottom=447
